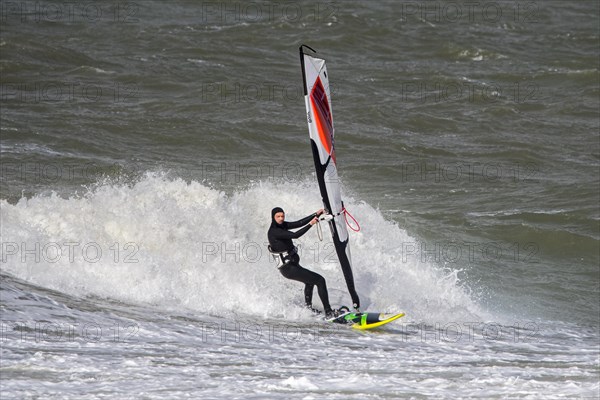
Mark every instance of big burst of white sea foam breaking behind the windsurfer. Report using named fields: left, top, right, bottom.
left=2, top=174, right=483, bottom=323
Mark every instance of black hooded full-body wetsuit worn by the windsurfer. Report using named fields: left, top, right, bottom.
left=267, top=209, right=331, bottom=314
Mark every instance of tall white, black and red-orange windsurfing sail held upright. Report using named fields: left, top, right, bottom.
left=300, top=45, right=360, bottom=309
